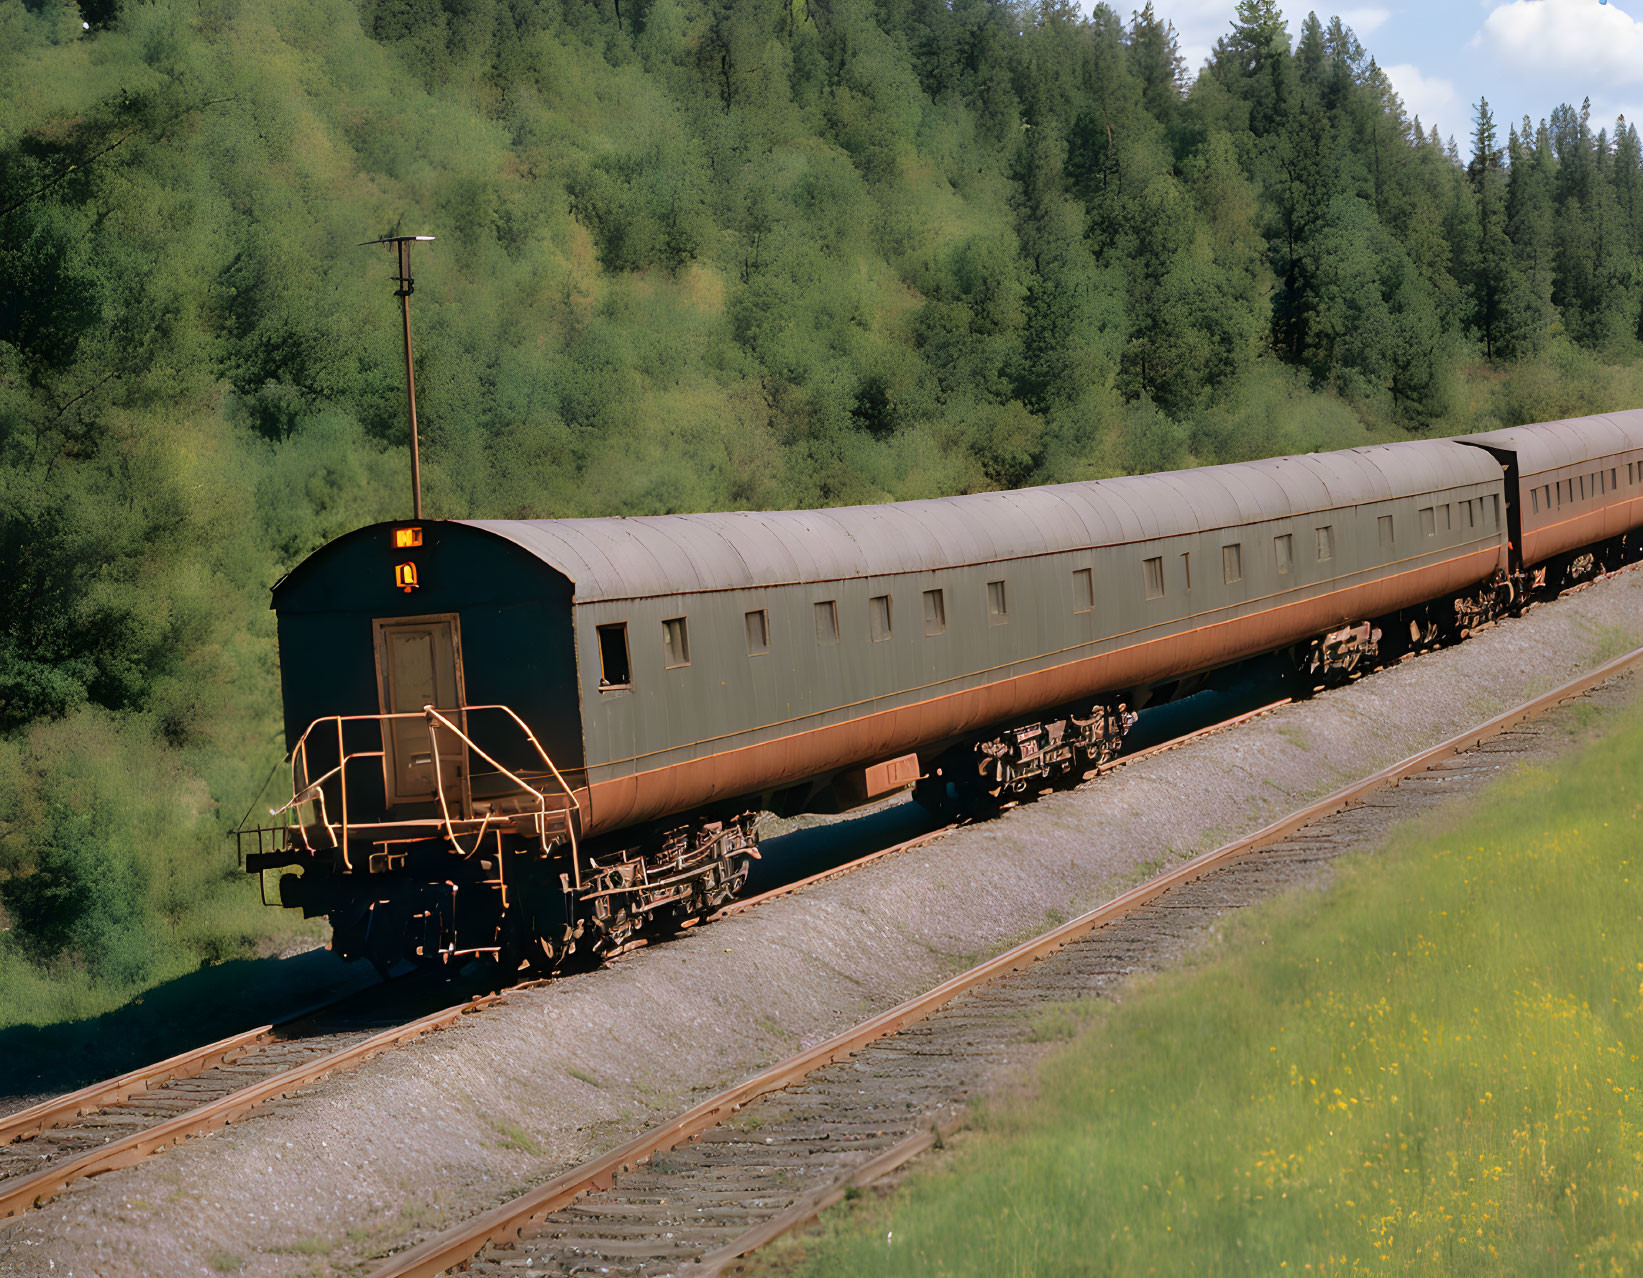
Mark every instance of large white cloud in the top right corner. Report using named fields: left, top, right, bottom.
left=1469, top=0, right=1643, bottom=92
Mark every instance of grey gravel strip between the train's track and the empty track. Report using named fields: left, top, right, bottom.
left=0, top=570, right=1643, bottom=1275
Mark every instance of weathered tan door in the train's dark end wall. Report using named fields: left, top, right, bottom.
left=371, top=613, right=472, bottom=816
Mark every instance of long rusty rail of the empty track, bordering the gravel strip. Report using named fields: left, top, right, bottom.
left=373, top=647, right=1643, bottom=1278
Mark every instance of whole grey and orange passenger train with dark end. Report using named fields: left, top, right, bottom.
left=238, top=411, right=1643, bottom=971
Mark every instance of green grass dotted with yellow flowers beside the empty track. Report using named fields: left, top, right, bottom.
left=769, top=693, right=1643, bottom=1275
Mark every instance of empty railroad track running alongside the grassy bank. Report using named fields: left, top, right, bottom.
left=375, top=649, right=1643, bottom=1278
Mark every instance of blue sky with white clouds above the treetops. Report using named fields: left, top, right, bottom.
left=1081, top=0, right=1643, bottom=156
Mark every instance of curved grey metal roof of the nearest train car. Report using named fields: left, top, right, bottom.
left=460, top=436, right=1504, bottom=601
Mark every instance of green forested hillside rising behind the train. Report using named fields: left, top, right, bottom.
left=0, top=0, right=1643, bottom=1023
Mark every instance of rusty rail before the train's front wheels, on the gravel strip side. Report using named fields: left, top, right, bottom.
left=0, top=994, right=504, bottom=1219
